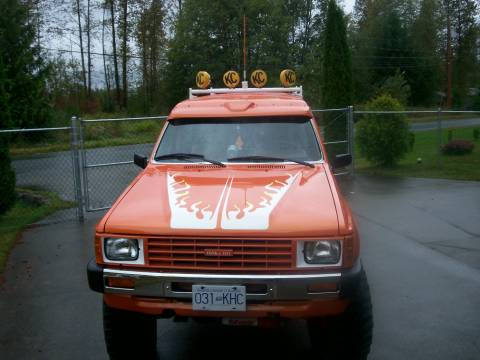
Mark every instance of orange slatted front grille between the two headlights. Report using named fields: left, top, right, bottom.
left=147, top=238, right=294, bottom=272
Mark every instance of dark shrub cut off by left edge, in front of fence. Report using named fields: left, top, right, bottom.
left=0, top=136, right=15, bottom=215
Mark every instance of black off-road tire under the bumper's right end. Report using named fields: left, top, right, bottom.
left=307, top=269, right=373, bottom=360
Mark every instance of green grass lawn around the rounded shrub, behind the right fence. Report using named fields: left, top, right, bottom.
left=356, top=126, right=480, bottom=181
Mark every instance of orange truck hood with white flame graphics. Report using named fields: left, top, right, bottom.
left=104, top=164, right=339, bottom=237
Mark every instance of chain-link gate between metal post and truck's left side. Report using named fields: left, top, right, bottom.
left=77, top=116, right=166, bottom=212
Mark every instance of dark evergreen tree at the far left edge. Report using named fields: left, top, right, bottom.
left=0, top=0, right=49, bottom=214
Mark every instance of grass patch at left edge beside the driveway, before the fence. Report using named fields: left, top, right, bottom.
left=0, top=189, right=74, bottom=273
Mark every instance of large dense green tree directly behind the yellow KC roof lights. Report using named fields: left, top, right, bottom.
left=166, top=0, right=304, bottom=106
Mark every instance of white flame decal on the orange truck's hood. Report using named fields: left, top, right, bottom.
left=167, top=173, right=299, bottom=230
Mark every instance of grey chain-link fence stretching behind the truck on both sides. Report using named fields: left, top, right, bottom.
left=0, top=107, right=480, bottom=222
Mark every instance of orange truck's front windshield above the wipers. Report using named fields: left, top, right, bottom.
left=155, top=117, right=322, bottom=162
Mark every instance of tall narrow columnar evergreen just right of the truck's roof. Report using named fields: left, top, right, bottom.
left=322, top=0, right=352, bottom=154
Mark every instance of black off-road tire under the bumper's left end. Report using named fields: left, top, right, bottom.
left=103, top=303, right=157, bottom=360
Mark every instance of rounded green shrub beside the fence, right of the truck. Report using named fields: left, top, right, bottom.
left=356, top=95, right=411, bottom=166
